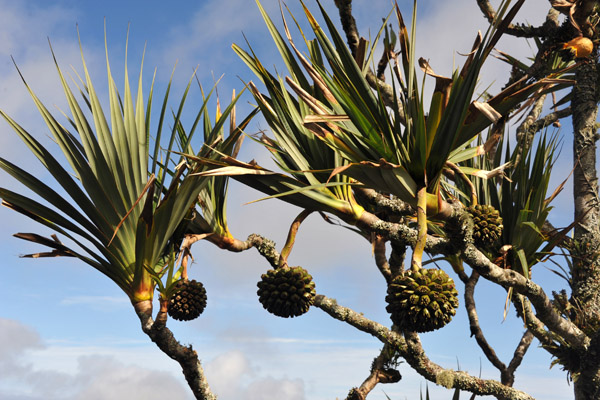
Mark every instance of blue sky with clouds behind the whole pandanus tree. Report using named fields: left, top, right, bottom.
left=0, top=0, right=572, bottom=400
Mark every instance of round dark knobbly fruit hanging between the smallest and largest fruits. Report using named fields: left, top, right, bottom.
left=257, top=266, right=316, bottom=318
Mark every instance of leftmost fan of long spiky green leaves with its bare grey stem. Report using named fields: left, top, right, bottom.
left=0, top=36, right=252, bottom=398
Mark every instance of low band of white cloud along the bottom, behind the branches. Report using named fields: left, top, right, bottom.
left=0, top=319, right=571, bottom=400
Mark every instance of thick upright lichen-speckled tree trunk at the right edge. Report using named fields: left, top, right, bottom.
left=571, top=55, right=600, bottom=400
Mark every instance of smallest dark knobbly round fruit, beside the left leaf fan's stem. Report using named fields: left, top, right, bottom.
left=168, top=280, right=206, bottom=321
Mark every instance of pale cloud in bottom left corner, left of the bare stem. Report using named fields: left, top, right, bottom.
left=0, top=318, right=190, bottom=400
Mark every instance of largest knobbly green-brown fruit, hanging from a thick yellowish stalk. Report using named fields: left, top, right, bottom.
left=385, top=268, right=458, bottom=332
